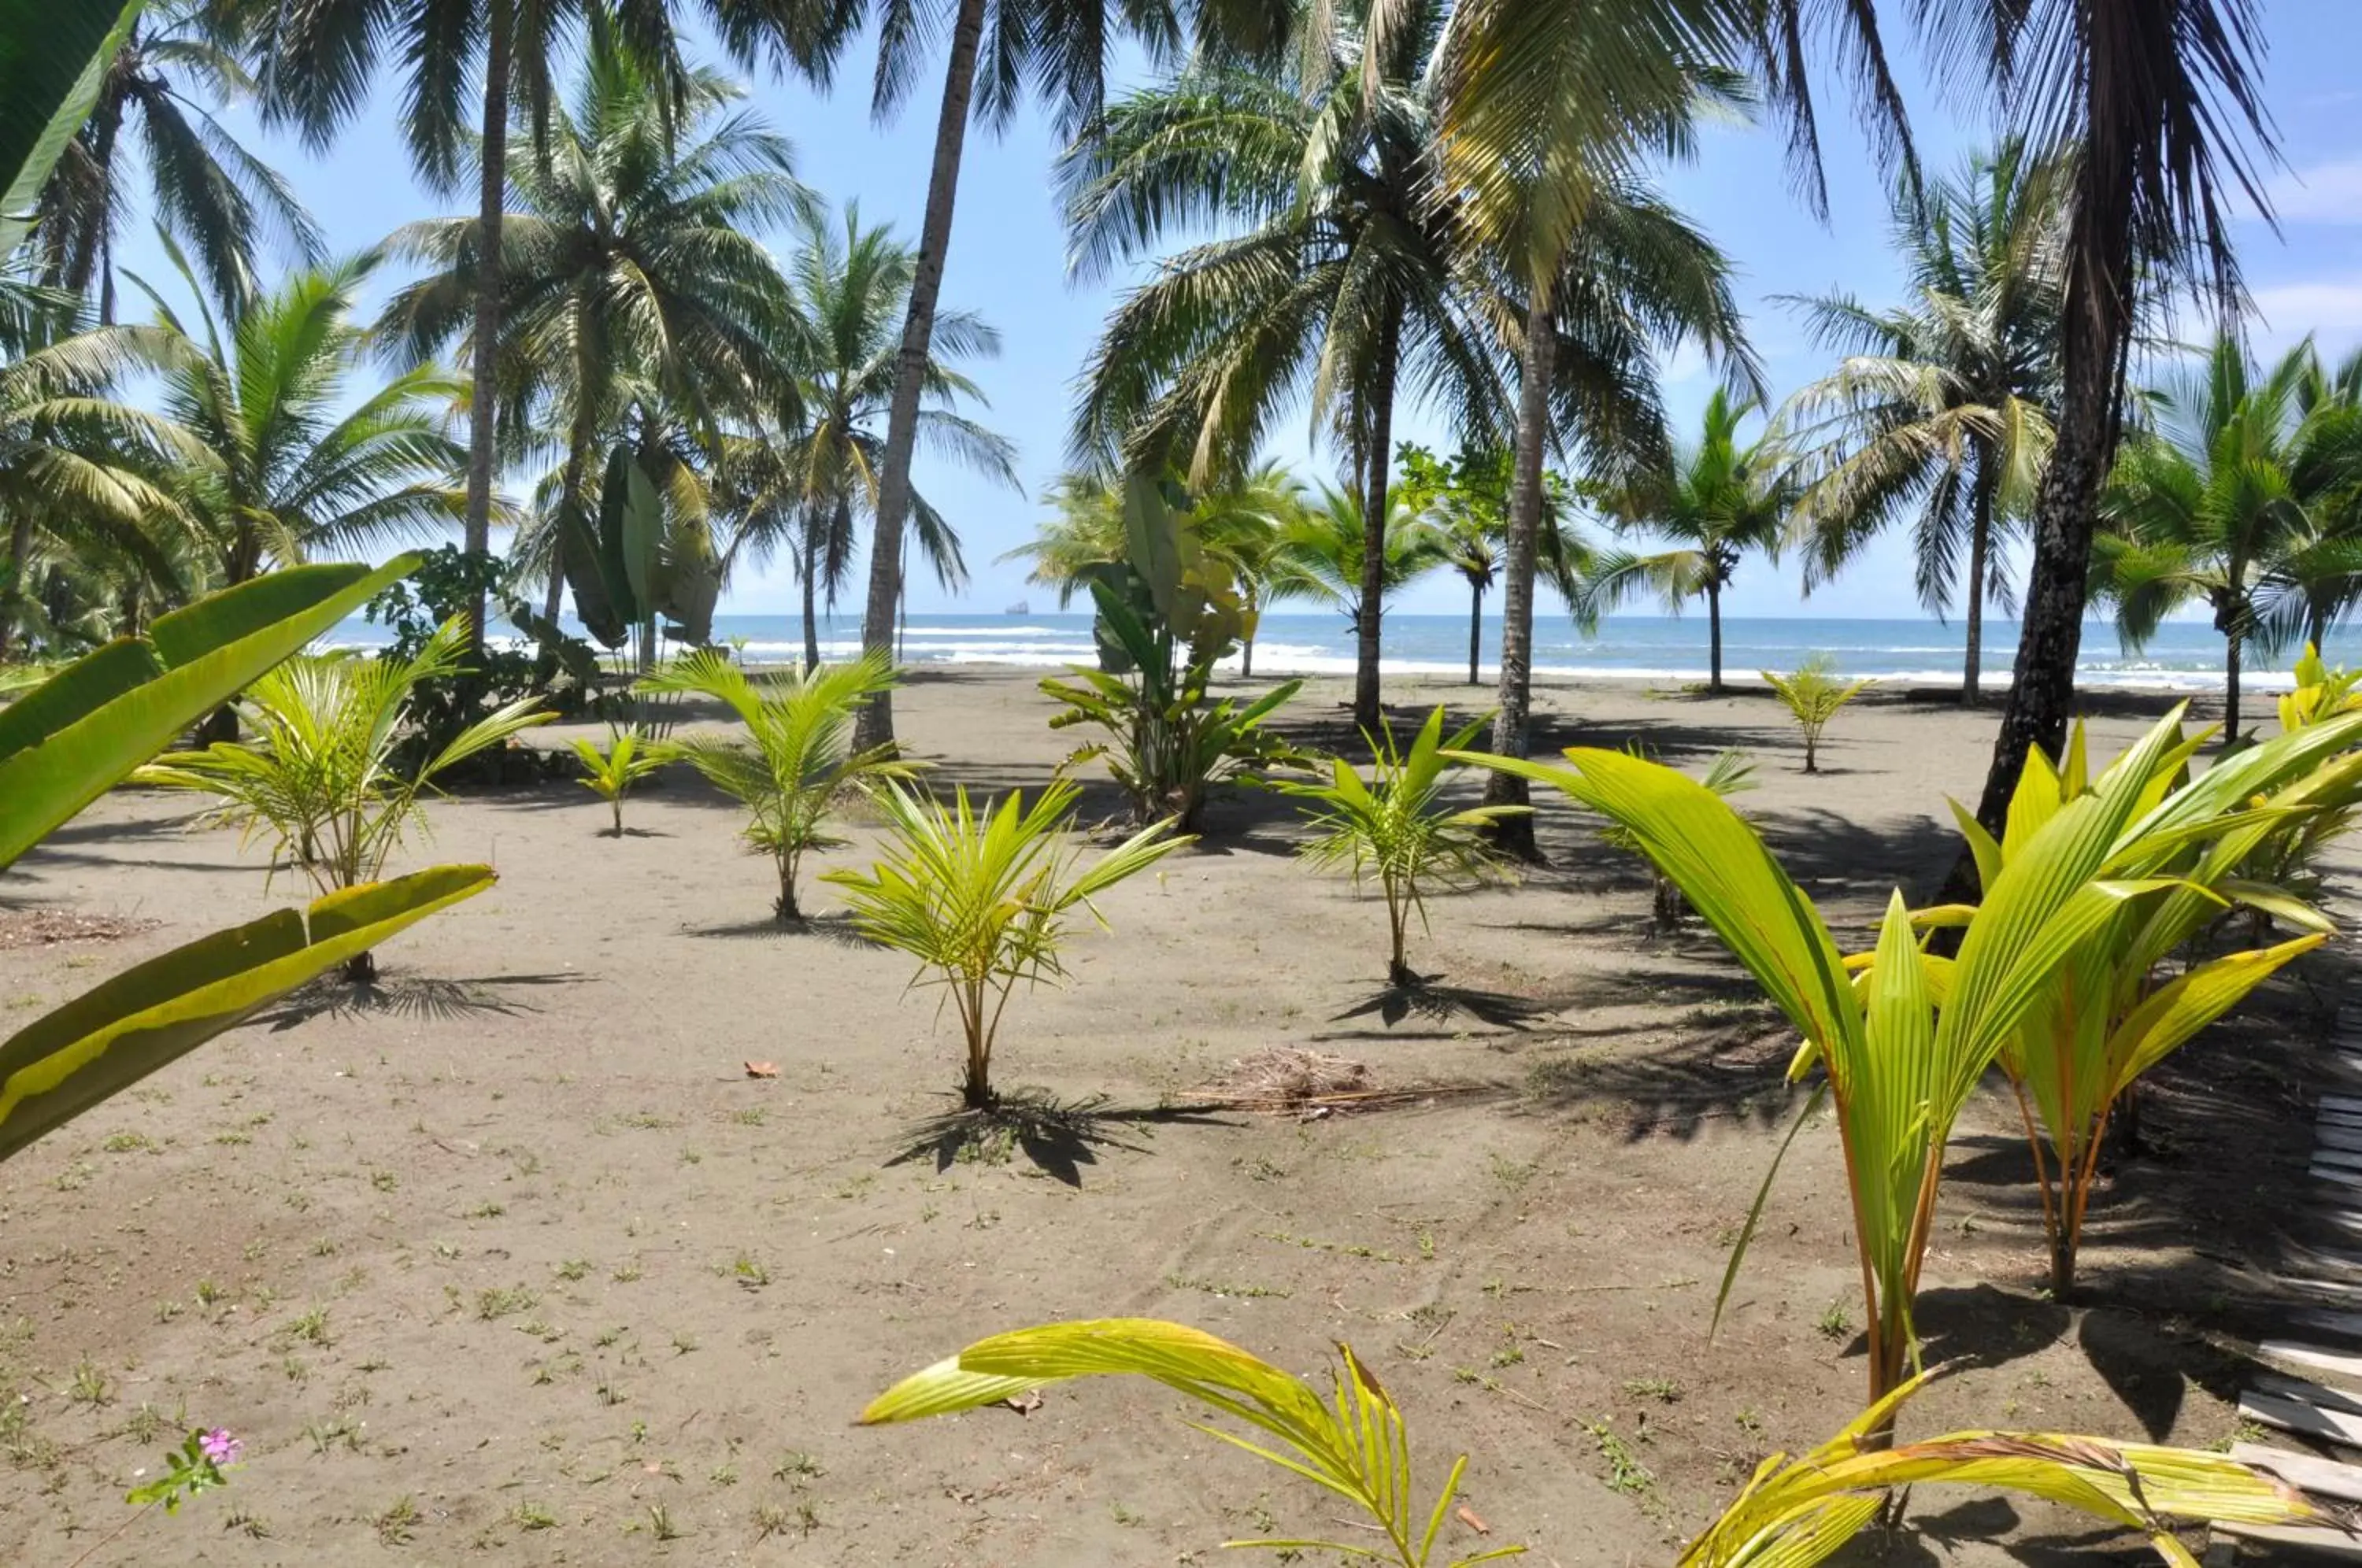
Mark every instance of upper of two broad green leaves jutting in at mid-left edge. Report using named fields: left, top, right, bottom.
left=0, top=555, right=418, bottom=869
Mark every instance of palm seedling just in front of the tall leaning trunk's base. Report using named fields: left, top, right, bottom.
left=638, top=649, right=916, bottom=923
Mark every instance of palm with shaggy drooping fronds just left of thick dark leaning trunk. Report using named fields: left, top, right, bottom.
left=1774, top=142, right=2064, bottom=704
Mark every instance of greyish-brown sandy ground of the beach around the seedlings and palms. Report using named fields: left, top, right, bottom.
left=0, top=671, right=2350, bottom=1568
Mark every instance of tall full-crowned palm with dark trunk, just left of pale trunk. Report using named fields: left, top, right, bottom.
left=1061, top=0, right=1505, bottom=727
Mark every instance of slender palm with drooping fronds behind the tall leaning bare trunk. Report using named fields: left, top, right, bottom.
left=730, top=203, right=1020, bottom=668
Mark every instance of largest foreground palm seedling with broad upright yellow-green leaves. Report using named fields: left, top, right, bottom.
left=1469, top=708, right=2362, bottom=1403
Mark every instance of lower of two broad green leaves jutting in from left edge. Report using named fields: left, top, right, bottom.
left=0, top=867, right=494, bottom=1159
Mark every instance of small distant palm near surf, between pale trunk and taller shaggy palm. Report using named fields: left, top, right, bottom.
left=1583, top=390, right=1795, bottom=694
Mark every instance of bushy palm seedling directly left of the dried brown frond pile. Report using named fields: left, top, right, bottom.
left=822, top=779, right=1190, bottom=1110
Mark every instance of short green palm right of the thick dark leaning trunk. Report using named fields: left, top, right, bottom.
left=2090, top=333, right=2357, bottom=746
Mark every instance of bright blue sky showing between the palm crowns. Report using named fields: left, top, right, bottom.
left=128, top=0, right=2362, bottom=616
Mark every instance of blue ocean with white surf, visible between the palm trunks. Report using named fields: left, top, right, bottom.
left=328, top=612, right=2362, bottom=692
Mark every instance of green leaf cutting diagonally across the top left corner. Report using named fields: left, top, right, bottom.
left=0, top=0, right=139, bottom=253
